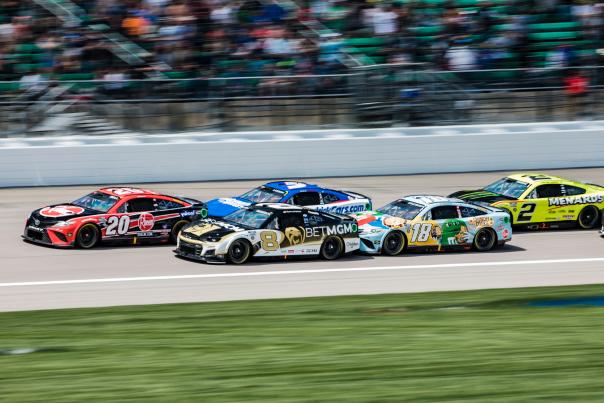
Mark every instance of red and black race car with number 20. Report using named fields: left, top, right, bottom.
left=23, top=187, right=208, bottom=249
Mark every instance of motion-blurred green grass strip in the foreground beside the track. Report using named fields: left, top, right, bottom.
left=0, top=286, right=604, bottom=402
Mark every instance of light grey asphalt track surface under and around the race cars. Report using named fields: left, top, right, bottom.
left=0, top=168, right=604, bottom=311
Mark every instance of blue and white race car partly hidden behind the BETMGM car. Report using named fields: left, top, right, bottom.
left=207, top=182, right=371, bottom=217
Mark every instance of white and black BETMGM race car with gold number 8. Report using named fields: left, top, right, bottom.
left=174, top=203, right=360, bottom=264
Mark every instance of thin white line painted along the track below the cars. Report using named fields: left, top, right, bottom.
left=0, top=257, right=604, bottom=287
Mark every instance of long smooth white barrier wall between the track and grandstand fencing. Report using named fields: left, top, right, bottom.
left=0, top=121, right=604, bottom=187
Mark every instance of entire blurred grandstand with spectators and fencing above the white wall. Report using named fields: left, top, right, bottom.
left=0, top=0, right=604, bottom=134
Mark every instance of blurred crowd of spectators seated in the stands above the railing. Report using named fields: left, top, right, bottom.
left=0, top=0, right=604, bottom=88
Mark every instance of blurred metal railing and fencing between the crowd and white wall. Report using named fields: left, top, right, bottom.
left=0, top=64, right=604, bottom=135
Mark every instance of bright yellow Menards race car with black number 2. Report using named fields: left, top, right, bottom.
left=450, top=173, right=604, bottom=229
